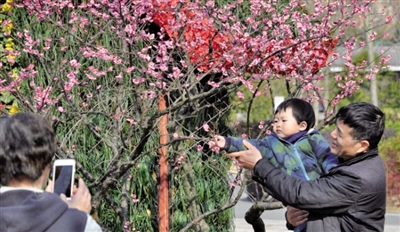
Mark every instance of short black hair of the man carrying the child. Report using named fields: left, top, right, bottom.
left=336, top=102, right=385, bottom=149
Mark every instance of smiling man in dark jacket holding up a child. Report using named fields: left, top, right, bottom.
left=229, top=103, right=386, bottom=232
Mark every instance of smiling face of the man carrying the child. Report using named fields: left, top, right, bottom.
left=331, top=120, right=364, bottom=159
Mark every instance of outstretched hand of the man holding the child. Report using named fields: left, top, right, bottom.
left=228, top=140, right=262, bottom=170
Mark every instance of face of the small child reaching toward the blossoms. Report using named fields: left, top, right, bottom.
left=272, top=108, right=307, bottom=138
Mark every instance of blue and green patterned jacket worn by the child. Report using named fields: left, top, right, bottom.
left=224, top=130, right=338, bottom=180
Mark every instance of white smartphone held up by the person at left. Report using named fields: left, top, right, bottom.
left=53, top=159, right=75, bottom=199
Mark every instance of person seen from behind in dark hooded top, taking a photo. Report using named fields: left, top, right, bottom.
left=0, top=113, right=101, bottom=232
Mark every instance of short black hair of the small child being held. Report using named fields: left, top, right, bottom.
left=275, top=98, right=315, bottom=130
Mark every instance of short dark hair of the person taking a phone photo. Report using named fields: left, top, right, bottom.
left=0, top=113, right=57, bottom=185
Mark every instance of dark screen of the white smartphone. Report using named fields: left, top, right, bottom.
left=54, top=165, right=73, bottom=198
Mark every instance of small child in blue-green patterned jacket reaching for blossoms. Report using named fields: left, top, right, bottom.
left=209, top=98, right=338, bottom=231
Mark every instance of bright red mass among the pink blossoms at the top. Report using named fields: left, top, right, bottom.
left=153, top=0, right=338, bottom=75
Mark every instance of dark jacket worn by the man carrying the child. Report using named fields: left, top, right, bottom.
left=253, top=148, right=386, bottom=232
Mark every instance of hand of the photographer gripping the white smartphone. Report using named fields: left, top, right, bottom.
left=61, top=178, right=92, bottom=214
